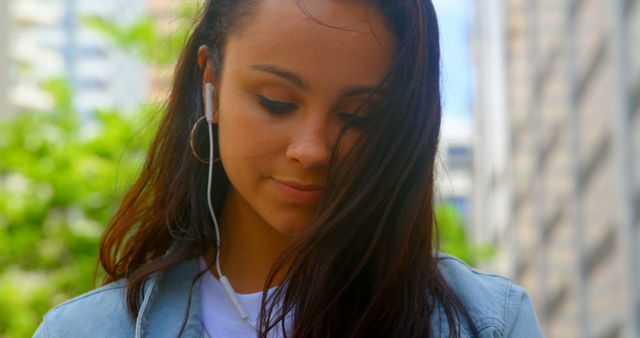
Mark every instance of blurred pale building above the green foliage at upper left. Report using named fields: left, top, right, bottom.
left=0, top=0, right=148, bottom=113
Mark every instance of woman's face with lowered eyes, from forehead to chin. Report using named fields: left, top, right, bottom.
left=208, top=0, right=394, bottom=235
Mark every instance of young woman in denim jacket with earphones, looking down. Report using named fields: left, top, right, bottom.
left=36, top=0, right=541, bottom=337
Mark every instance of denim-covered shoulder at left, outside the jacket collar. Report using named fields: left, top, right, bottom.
left=34, top=280, right=133, bottom=337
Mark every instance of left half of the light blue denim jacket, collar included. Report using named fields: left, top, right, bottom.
left=34, top=260, right=202, bottom=338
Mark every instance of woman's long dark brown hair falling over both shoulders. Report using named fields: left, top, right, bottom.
left=99, top=0, right=476, bottom=337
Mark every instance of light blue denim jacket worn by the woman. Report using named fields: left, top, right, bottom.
left=34, top=255, right=542, bottom=338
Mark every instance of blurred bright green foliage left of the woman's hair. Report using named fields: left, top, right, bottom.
left=0, top=79, right=158, bottom=337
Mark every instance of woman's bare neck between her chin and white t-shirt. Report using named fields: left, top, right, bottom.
left=210, top=189, right=293, bottom=293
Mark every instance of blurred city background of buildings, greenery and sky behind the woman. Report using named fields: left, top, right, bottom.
left=0, top=0, right=640, bottom=338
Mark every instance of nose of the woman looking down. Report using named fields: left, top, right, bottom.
left=286, top=121, right=332, bottom=168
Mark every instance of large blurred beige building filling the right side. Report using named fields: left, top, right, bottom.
left=472, top=0, right=640, bottom=338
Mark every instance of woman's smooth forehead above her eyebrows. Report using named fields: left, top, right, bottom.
left=225, top=0, right=394, bottom=87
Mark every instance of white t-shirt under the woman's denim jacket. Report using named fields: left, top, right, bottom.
left=200, top=260, right=291, bottom=338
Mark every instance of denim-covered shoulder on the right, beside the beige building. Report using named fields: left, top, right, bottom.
left=438, top=254, right=542, bottom=337
